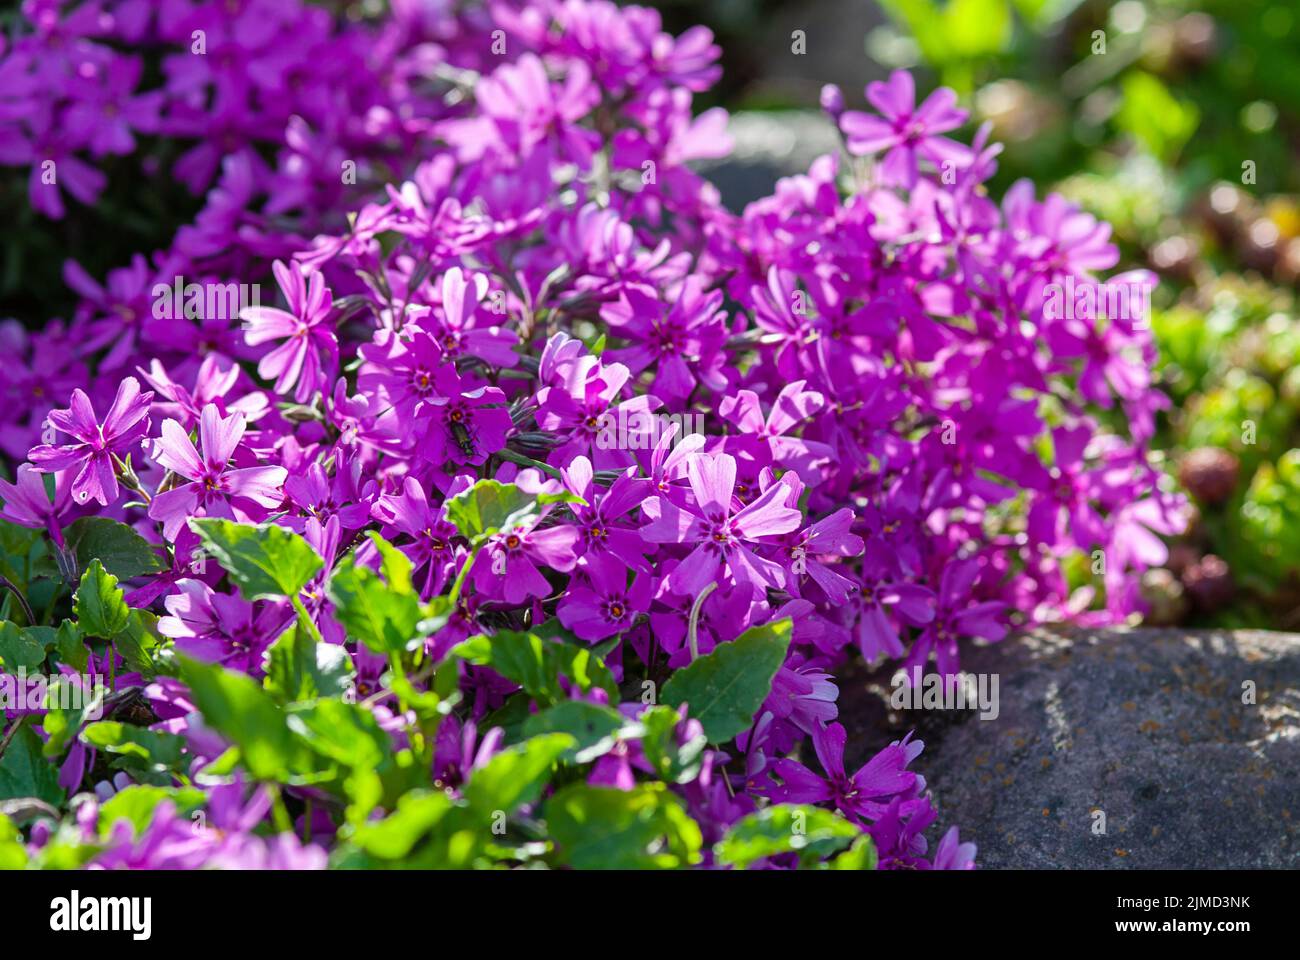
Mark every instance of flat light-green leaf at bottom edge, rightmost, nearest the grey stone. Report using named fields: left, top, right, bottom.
left=714, top=804, right=870, bottom=869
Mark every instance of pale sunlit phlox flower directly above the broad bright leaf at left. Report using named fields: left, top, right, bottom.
left=150, top=403, right=289, bottom=541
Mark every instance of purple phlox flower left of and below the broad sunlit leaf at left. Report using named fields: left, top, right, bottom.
left=157, top=579, right=294, bottom=676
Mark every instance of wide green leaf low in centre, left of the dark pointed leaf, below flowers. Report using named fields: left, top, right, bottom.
left=438, top=630, right=619, bottom=706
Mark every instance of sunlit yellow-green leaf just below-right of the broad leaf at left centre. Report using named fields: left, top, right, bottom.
left=328, top=557, right=423, bottom=653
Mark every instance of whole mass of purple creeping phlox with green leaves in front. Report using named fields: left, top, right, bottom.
left=0, top=0, right=1182, bottom=869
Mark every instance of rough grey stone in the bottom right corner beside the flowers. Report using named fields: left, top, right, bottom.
left=842, top=630, right=1300, bottom=869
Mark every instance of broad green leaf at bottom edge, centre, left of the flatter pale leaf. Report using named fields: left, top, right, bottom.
left=543, top=783, right=703, bottom=870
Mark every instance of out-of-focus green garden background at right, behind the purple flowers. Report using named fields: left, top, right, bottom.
left=657, top=0, right=1300, bottom=630
